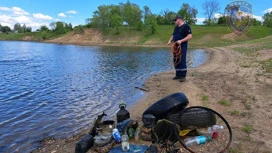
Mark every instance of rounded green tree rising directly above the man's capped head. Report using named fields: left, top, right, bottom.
left=178, top=3, right=198, bottom=24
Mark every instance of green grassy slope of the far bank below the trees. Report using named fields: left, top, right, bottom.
left=0, top=25, right=272, bottom=48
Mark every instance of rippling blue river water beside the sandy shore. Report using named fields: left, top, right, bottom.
left=0, top=41, right=208, bottom=152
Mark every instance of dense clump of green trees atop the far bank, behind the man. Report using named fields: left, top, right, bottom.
left=86, top=1, right=198, bottom=34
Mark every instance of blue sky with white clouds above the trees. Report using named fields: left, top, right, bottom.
left=0, top=0, right=272, bottom=30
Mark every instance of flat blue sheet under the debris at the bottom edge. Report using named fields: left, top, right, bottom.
left=109, top=144, right=149, bottom=153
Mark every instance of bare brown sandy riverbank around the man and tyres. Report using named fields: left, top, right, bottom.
left=35, top=47, right=272, bottom=153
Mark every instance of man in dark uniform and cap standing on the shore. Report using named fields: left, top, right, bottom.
left=168, top=16, right=192, bottom=82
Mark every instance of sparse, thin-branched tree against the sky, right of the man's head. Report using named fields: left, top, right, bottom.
left=202, top=0, right=220, bottom=25
